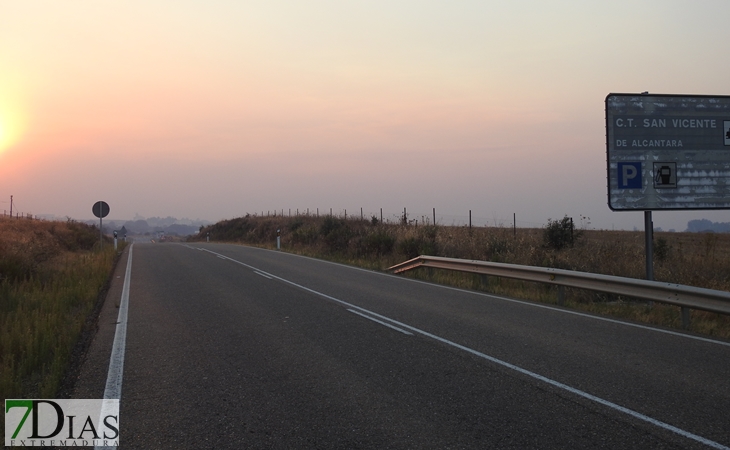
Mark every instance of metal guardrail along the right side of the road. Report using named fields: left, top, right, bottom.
left=387, top=256, right=730, bottom=318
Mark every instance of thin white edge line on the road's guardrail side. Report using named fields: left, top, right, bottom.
left=186, top=246, right=730, bottom=347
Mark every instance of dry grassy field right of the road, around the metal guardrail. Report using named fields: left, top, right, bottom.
left=190, top=215, right=730, bottom=338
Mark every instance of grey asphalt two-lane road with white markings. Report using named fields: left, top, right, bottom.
left=74, top=244, right=730, bottom=449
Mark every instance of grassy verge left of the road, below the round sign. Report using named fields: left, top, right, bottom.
left=0, top=219, right=116, bottom=399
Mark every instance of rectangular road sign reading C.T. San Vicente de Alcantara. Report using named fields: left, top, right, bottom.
left=606, top=93, right=730, bottom=211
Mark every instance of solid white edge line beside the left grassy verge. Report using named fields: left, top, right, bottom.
left=95, top=243, right=134, bottom=449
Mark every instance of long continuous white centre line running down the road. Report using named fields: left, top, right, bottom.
left=192, top=249, right=730, bottom=450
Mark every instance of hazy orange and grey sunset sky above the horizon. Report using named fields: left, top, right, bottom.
left=0, top=0, right=730, bottom=230
